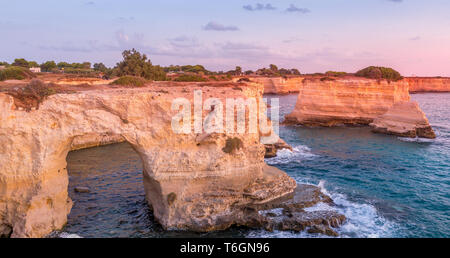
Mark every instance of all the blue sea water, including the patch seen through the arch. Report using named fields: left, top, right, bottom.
left=63, top=93, right=450, bottom=237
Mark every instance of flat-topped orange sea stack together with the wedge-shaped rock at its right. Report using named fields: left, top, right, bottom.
left=285, top=78, right=434, bottom=138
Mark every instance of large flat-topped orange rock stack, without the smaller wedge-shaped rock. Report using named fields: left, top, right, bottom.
left=285, top=78, right=410, bottom=126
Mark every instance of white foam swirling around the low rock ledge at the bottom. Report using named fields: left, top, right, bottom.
left=248, top=181, right=399, bottom=238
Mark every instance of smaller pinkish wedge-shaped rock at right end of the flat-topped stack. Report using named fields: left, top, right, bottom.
left=370, top=102, right=436, bottom=139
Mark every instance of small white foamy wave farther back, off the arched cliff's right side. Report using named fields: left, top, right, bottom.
left=266, top=145, right=317, bottom=165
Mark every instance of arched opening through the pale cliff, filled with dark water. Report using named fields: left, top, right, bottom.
left=62, top=142, right=161, bottom=237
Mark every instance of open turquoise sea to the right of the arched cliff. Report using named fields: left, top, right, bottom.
left=268, top=93, right=450, bottom=237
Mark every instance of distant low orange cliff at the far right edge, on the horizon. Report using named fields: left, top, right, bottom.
left=404, top=77, right=450, bottom=93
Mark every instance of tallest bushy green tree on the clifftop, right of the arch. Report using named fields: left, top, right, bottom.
left=116, top=48, right=166, bottom=80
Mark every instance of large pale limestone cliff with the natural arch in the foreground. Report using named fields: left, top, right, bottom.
left=0, top=84, right=296, bottom=237
